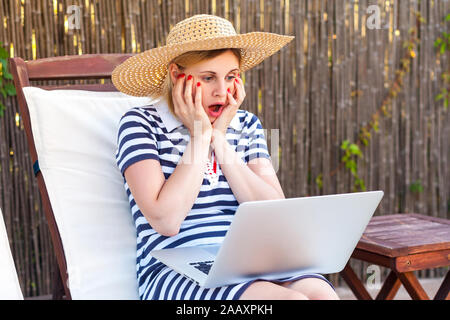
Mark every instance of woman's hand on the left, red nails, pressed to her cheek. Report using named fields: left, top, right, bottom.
left=172, top=74, right=212, bottom=138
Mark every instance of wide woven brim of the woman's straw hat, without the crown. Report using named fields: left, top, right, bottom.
left=111, top=32, right=294, bottom=97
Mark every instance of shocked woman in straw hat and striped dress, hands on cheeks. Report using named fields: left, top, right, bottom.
left=112, top=15, right=337, bottom=299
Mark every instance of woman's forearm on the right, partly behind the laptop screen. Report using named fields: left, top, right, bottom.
left=212, top=136, right=284, bottom=203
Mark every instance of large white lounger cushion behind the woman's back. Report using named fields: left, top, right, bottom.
left=23, top=87, right=155, bottom=299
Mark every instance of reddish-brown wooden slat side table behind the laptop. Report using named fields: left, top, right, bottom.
left=341, top=213, right=450, bottom=300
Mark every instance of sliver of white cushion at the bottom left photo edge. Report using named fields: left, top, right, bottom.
left=0, top=209, right=23, bottom=300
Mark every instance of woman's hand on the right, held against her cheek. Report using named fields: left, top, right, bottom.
left=211, top=78, right=245, bottom=142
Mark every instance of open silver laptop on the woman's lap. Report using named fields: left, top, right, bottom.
left=150, top=191, right=383, bottom=288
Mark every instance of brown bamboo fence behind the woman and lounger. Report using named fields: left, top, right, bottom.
left=0, top=0, right=450, bottom=296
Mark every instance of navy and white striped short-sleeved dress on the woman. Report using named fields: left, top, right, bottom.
left=116, top=100, right=331, bottom=300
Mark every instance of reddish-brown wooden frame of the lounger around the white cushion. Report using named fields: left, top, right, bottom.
left=9, top=54, right=133, bottom=299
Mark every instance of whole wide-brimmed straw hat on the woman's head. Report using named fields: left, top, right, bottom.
left=111, top=14, right=294, bottom=97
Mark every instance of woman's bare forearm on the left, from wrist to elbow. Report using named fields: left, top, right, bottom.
left=157, top=137, right=210, bottom=234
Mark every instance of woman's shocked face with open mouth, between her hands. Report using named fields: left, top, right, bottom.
left=170, top=50, right=239, bottom=123
